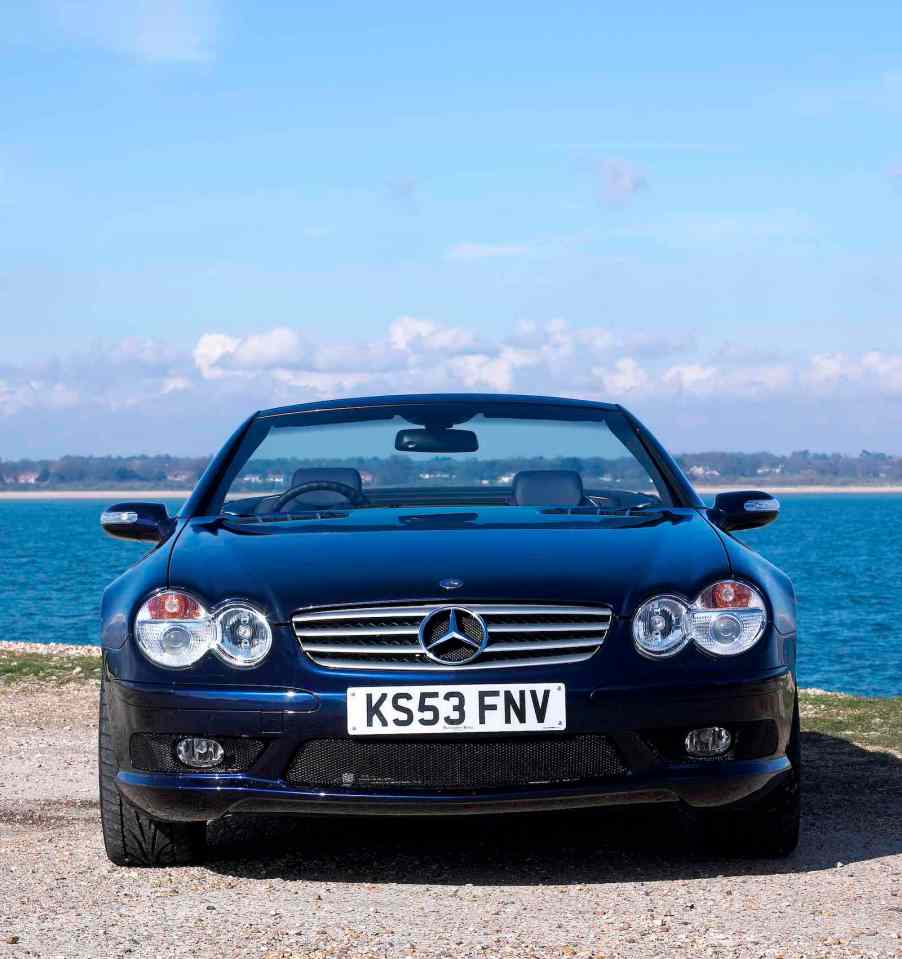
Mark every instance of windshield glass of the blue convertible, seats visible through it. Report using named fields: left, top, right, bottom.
left=223, top=407, right=671, bottom=517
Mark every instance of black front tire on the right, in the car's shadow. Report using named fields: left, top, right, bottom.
left=701, top=697, right=802, bottom=858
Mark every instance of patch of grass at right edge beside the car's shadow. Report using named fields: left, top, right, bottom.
left=799, top=691, right=902, bottom=752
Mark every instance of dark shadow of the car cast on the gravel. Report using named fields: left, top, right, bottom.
left=207, top=733, right=902, bottom=886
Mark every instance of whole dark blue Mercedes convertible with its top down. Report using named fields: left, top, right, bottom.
left=100, top=394, right=800, bottom=865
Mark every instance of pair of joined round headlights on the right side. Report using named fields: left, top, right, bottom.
left=633, top=579, right=767, bottom=659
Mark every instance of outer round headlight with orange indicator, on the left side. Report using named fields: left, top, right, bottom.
left=135, top=590, right=216, bottom=669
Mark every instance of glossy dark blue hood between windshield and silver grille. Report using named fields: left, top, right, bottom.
left=169, top=507, right=730, bottom=622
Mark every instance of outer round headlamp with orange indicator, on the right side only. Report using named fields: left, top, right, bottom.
left=691, top=579, right=767, bottom=656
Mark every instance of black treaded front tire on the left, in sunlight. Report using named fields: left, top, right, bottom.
left=97, top=678, right=207, bottom=866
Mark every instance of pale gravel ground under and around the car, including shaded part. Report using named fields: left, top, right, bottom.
left=0, top=682, right=902, bottom=959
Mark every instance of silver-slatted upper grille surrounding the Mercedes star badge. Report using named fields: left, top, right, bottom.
left=292, top=603, right=611, bottom=671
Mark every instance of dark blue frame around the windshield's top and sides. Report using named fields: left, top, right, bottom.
left=179, top=394, right=704, bottom=518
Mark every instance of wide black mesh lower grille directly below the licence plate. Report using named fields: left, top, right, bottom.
left=285, top=735, right=628, bottom=790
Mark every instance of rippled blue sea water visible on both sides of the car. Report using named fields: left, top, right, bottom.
left=0, top=494, right=902, bottom=696
